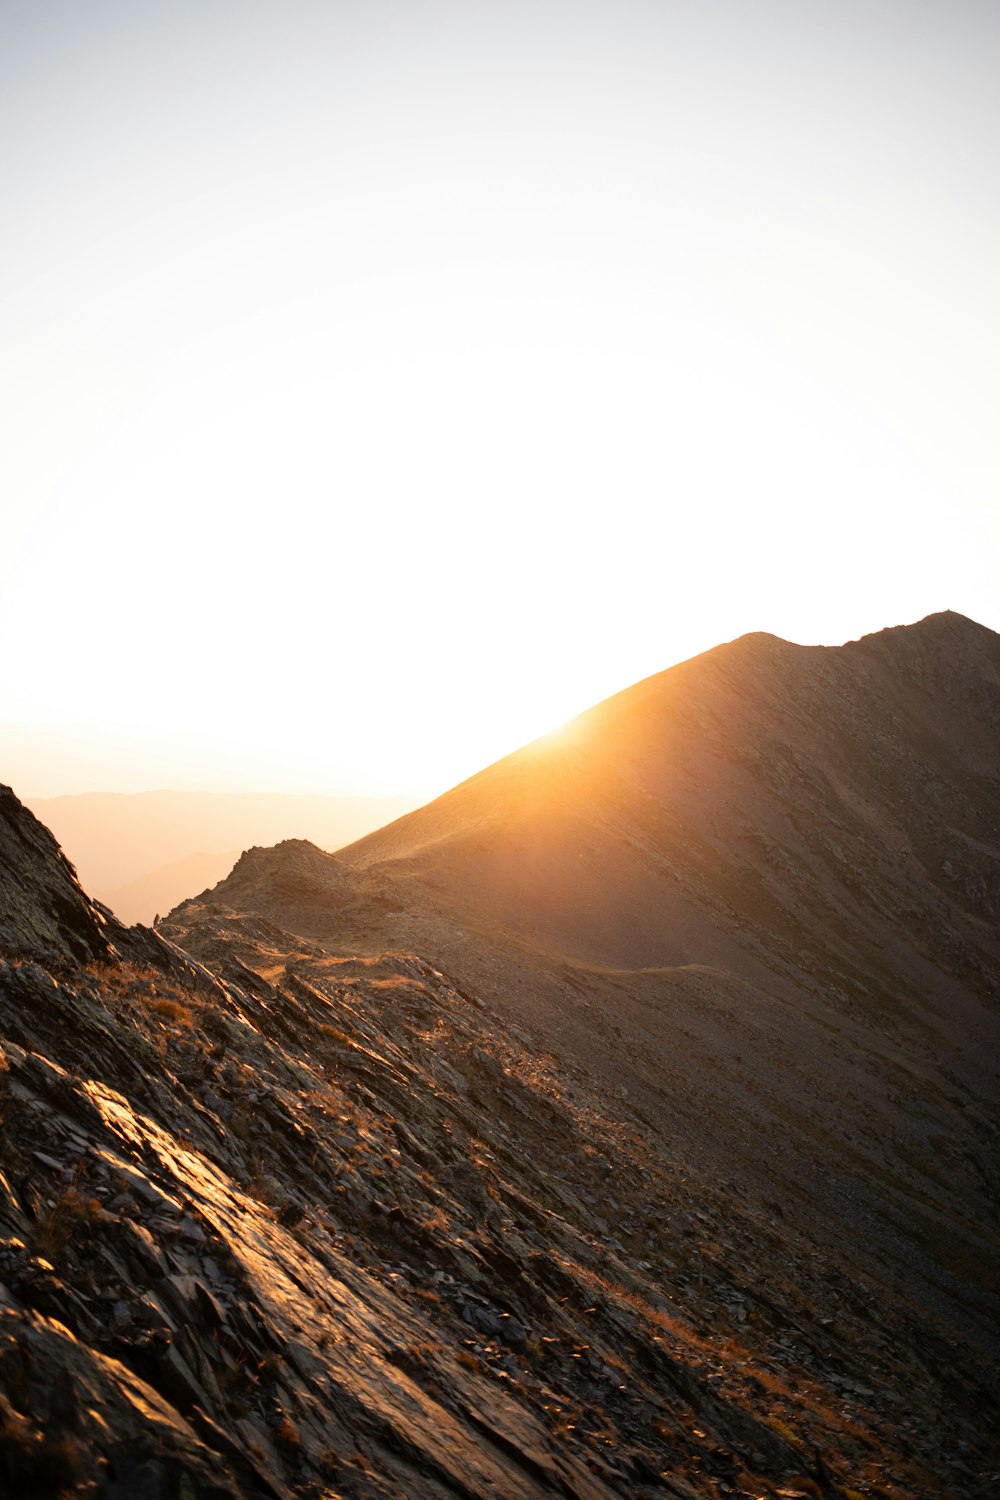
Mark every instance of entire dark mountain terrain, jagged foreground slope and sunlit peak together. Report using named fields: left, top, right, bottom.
left=0, top=615, right=1000, bottom=1500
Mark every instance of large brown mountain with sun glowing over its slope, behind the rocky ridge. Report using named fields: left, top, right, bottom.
left=168, top=614, right=1000, bottom=1488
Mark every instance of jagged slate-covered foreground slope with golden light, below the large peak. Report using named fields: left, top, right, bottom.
left=0, top=792, right=996, bottom=1500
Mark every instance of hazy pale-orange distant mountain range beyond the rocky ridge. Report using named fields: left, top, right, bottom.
left=28, top=792, right=414, bottom=923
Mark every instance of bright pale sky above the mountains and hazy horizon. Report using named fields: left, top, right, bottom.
left=0, top=0, right=1000, bottom=797
